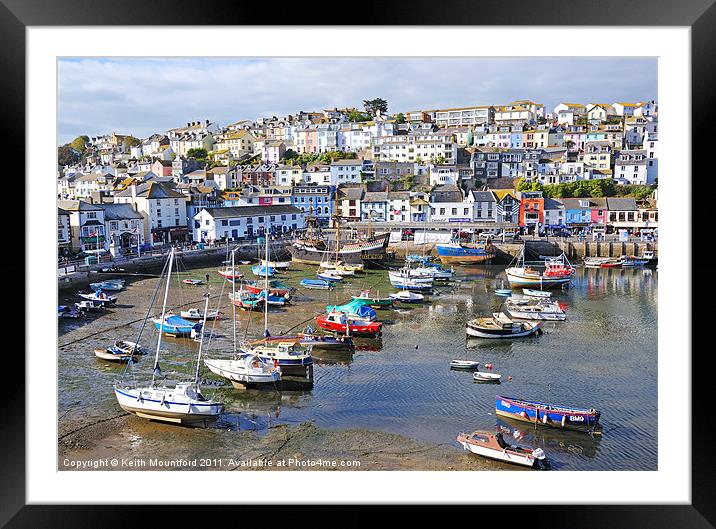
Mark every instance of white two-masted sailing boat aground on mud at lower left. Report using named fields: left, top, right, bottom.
left=113, top=248, right=224, bottom=426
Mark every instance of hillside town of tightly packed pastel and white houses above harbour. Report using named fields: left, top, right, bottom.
left=57, top=98, right=658, bottom=259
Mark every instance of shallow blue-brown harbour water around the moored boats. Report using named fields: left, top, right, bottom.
left=58, top=265, right=658, bottom=470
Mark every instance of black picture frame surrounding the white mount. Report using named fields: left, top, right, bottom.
left=5, top=0, right=716, bottom=529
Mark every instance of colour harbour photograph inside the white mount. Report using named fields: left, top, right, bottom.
left=56, top=55, right=660, bottom=476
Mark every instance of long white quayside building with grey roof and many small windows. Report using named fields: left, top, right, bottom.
left=193, top=205, right=305, bottom=242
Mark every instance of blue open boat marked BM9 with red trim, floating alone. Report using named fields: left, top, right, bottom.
left=495, top=395, right=601, bottom=431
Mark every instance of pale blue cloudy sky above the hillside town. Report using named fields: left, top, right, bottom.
left=58, top=57, right=658, bottom=144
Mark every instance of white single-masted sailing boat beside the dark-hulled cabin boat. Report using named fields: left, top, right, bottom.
left=204, top=248, right=281, bottom=389
